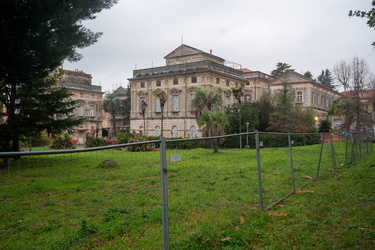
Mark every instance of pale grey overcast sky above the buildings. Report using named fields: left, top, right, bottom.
left=63, top=0, right=375, bottom=91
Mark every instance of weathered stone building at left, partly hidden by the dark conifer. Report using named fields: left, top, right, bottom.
left=58, top=69, right=104, bottom=144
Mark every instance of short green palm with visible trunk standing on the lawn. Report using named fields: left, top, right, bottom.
left=198, top=111, right=228, bottom=154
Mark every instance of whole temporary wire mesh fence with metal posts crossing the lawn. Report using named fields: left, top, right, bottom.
left=0, top=131, right=374, bottom=249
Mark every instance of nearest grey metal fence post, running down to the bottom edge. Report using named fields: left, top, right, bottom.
left=160, top=137, right=169, bottom=250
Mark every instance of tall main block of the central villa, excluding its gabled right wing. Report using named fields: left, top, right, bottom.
left=129, top=44, right=272, bottom=138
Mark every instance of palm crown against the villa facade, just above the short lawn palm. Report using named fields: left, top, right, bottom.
left=191, top=89, right=223, bottom=121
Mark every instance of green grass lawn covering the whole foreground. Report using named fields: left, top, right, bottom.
left=0, top=143, right=375, bottom=249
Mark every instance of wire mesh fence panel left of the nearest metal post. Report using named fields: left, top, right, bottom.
left=0, top=144, right=162, bottom=249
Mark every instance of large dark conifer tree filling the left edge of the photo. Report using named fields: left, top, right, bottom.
left=0, top=0, right=116, bottom=158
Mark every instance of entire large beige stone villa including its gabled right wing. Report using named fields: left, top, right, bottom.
left=129, top=44, right=350, bottom=138
